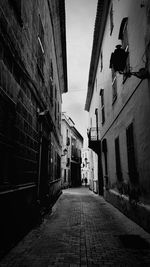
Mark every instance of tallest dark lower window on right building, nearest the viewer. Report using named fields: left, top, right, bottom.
left=126, top=123, right=137, bottom=182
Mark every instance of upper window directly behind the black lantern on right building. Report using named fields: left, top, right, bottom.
left=118, top=17, right=130, bottom=81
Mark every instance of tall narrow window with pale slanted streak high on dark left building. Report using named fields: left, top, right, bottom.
left=37, top=15, right=44, bottom=78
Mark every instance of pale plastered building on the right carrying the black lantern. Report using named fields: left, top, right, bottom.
left=85, top=0, right=150, bottom=230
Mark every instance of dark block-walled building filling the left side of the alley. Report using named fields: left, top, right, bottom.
left=0, top=0, right=67, bottom=255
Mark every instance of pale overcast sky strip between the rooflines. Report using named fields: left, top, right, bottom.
left=62, top=0, right=97, bottom=147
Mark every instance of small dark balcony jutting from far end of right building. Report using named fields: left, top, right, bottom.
left=87, top=127, right=101, bottom=154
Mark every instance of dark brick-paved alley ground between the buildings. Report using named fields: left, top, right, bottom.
left=0, top=188, right=150, bottom=267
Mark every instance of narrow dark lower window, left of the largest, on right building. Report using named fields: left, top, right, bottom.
left=115, top=137, right=122, bottom=181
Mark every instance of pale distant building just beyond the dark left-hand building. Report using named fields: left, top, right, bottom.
left=61, top=113, right=83, bottom=188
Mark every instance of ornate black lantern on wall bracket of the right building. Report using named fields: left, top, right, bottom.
left=110, top=45, right=149, bottom=80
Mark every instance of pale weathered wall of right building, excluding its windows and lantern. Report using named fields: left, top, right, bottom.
left=86, top=0, right=150, bottom=230
